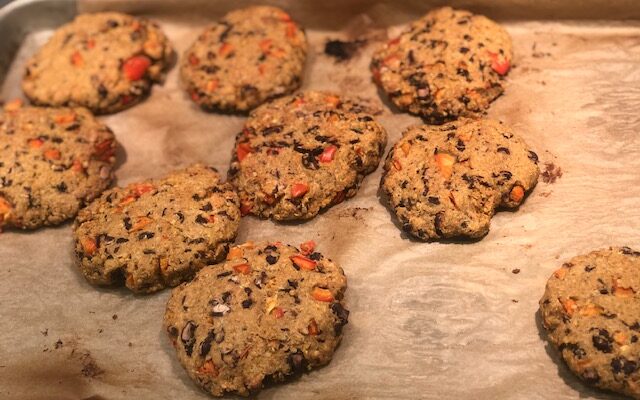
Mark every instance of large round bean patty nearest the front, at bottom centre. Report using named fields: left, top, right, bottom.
left=164, top=242, right=349, bottom=396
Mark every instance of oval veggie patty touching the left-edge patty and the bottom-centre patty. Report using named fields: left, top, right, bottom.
left=74, top=164, right=240, bottom=293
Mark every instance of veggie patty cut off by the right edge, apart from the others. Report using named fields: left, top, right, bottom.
left=540, top=247, right=640, bottom=399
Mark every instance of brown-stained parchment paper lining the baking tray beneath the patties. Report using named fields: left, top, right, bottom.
left=0, top=0, right=640, bottom=400
